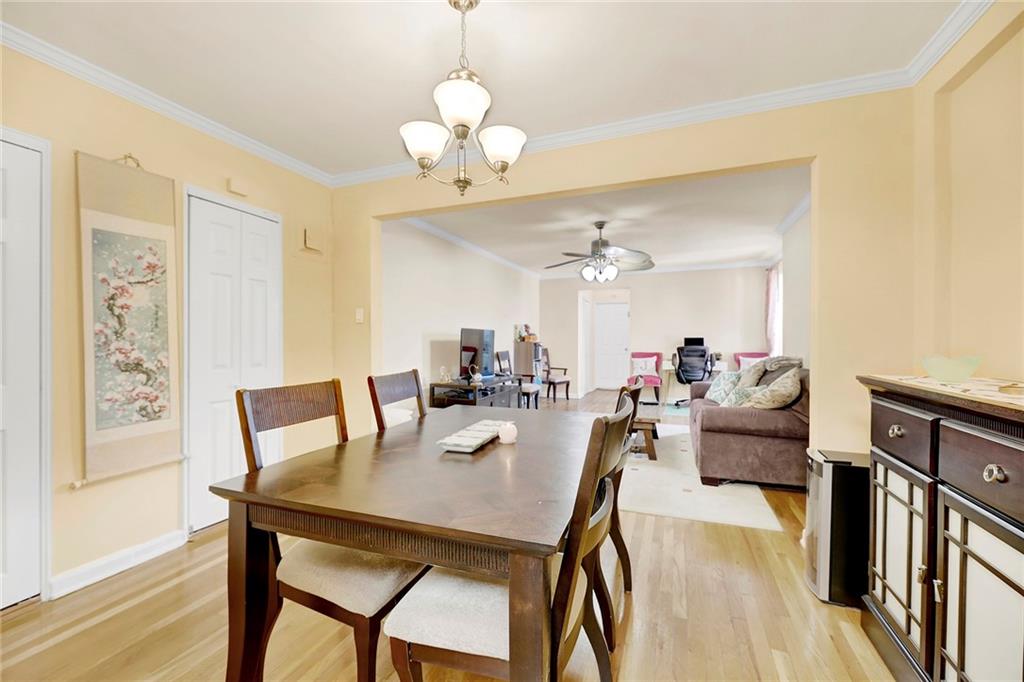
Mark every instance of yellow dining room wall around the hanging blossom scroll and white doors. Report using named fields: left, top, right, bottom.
left=0, top=48, right=334, bottom=574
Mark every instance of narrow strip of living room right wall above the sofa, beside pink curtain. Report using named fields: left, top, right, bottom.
left=782, top=214, right=812, bottom=367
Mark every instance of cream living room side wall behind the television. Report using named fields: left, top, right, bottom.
left=380, top=221, right=540, bottom=382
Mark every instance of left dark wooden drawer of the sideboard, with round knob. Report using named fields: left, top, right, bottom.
left=871, top=398, right=939, bottom=474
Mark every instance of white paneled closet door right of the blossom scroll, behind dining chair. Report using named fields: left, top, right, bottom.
left=186, top=197, right=284, bottom=529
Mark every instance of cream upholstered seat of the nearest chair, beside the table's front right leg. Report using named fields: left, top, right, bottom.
left=384, top=554, right=587, bottom=660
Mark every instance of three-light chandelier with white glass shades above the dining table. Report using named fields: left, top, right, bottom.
left=398, top=0, right=526, bottom=196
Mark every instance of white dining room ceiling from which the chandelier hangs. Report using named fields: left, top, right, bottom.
left=3, top=0, right=956, bottom=180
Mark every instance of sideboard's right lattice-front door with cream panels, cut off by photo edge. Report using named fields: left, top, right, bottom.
left=935, top=486, right=1024, bottom=682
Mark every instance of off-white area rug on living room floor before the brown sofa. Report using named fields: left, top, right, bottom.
left=618, top=424, right=782, bottom=530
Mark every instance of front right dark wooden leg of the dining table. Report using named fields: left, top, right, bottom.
left=509, top=554, right=557, bottom=682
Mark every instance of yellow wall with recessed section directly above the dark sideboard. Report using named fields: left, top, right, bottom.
left=913, top=3, right=1024, bottom=379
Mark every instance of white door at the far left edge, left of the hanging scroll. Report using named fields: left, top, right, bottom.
left=0, top=135, right=43, bottom=607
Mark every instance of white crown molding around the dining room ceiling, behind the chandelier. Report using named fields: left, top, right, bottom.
left=0, top=0, right=994, bottom=187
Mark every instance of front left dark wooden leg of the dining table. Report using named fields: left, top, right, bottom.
left=226, top=502, right=281, bottom=682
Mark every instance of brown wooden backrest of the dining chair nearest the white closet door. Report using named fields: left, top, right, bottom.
left=234, top=379, right=348, bottom=473
